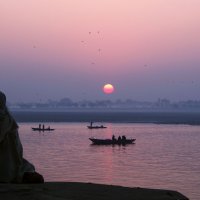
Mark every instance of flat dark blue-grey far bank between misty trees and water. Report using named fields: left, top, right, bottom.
left=11, top=111, right=200, bottom=125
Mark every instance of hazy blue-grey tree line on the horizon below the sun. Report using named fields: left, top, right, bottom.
left=9, top=98, right=200, bottom=110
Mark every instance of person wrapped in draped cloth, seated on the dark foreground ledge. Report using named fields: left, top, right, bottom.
left=0, top=91, right=44, bottom=183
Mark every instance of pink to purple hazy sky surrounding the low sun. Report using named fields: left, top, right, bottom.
left=0, top=0, right=200, bottom=101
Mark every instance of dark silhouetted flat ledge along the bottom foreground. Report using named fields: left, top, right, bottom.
left=0, top=182, right=188, bottom=200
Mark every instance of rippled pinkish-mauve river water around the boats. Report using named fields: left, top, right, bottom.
left=19, top=123, right=200, bottom=200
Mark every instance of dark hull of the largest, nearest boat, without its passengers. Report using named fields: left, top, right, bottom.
left=89, top=138, right=136, bottom=145
